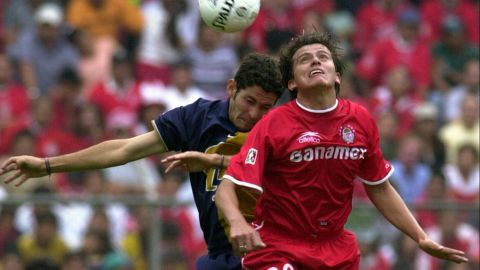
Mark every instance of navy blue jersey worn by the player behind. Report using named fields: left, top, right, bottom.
left=154, top=99, right=239, bottom=254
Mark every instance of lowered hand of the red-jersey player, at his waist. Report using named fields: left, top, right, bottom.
left=230, top=219, right=266, bottom=256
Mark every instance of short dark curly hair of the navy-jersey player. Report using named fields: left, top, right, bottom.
left=234, top=53, right=284, bottom=97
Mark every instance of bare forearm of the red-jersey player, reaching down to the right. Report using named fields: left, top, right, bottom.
left=365, top=181, right=426, bottom=243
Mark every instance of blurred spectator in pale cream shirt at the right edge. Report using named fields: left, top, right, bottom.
left=439, top=93, right=480, bottom=163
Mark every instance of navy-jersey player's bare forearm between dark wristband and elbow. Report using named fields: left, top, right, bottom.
left=49, top=140, right=128, bottom=173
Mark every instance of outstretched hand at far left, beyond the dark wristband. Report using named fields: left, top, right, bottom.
left=0, top=156, right=47, bottom=186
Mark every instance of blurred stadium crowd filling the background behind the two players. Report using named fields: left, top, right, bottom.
left=0, top=0, right=480, bottom=270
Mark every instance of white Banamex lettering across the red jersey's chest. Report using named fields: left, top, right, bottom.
left=290, top=146, right=367, bottom=162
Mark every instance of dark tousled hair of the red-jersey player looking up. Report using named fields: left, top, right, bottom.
left=280, top=32, right=345, bottom=98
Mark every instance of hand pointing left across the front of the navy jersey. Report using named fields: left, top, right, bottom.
left=162, top=151, right=218, bottom=173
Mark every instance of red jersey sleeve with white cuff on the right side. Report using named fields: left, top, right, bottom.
left=358, top=110, right=393, bottom=185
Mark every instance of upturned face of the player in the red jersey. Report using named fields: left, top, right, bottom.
left=288, top=44, right=340, bottom=92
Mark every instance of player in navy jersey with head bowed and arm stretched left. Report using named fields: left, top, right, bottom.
left=0, top=53, right=283, bottom=270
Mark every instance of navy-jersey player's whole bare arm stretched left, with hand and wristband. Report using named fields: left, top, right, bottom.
left=0, top=131, right=166, bottom=186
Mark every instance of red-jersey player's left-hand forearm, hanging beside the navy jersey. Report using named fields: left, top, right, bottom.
left=215, top=179, right=246, bottom=225
